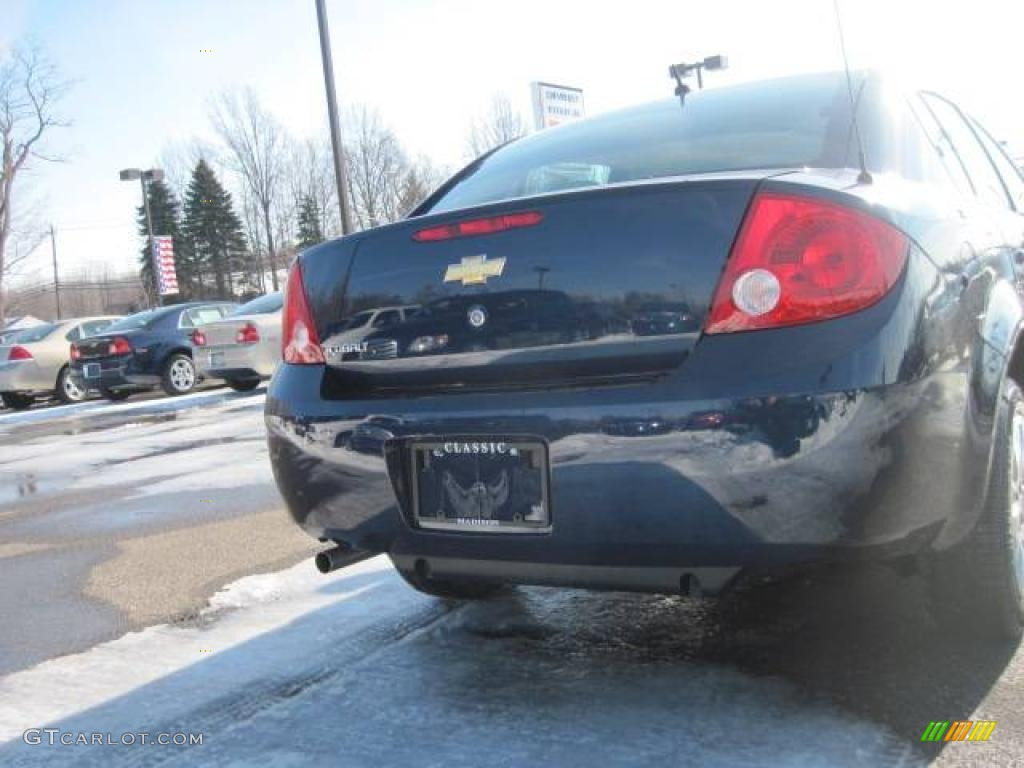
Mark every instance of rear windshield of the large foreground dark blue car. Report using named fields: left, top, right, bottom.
left=421, top=73, right=857, bottom=213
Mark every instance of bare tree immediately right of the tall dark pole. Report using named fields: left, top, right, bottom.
left=345, top=106, right=409, bottom=229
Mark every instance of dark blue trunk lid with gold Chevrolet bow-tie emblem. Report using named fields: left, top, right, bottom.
left=303, top=173, right=767, bottom=396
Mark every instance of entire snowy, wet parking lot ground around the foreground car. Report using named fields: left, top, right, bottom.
left=0, top=388, right=1024, bottom=766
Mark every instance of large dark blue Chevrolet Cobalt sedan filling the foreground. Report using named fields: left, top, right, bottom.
left=266, top=73, right=1024, bottom=635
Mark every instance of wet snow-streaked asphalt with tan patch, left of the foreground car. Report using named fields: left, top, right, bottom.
left=0, top=390, right=316, bottom=675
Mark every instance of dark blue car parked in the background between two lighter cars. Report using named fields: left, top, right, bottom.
left=71, top=301, right=237, bottom=400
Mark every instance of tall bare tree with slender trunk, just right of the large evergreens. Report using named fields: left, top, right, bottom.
left=212, top=88, right=288, bottom=291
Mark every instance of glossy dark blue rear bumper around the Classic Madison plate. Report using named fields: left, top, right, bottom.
left=267, top=367, right=939, bottom=566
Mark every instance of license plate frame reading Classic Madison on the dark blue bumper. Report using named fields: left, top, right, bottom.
left=409, top=436, right=552, bottom=536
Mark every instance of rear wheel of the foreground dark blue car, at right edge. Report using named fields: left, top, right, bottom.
left=929, top=379, right=1024, bottom=639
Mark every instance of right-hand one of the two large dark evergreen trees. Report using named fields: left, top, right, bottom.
left=181, top=159, right=246, bottom=298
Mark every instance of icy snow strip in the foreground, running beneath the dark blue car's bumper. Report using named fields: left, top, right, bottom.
left=0, top=558, right=916, bottom=768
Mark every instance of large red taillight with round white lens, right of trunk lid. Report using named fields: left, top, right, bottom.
left=707, top=193, right=909, bottom=334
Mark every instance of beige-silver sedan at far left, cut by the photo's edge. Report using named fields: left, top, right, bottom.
left=0, top=316, right=119, bottom=409
